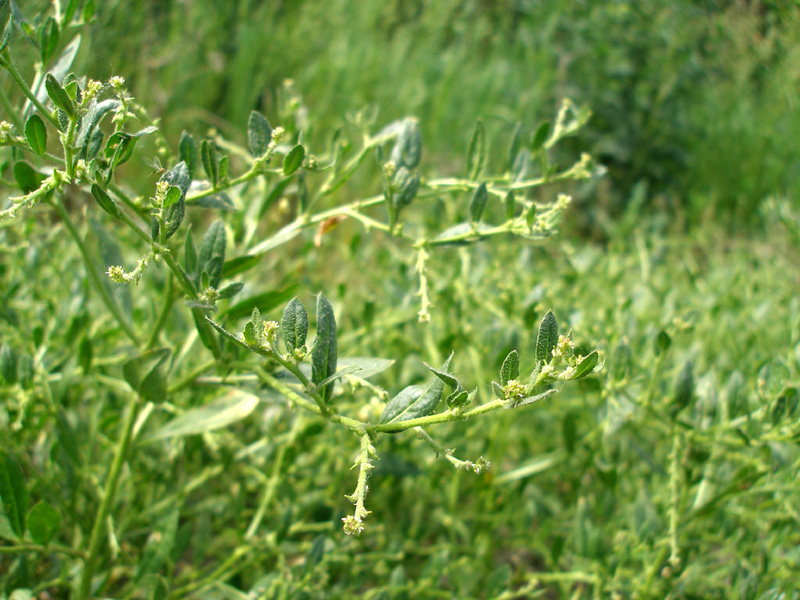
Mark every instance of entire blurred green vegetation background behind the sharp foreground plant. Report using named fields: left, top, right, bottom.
left=4, top=0, right=800, bottom=600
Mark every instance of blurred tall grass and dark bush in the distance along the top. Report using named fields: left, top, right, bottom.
left=59, top=0, right=800, bottom=228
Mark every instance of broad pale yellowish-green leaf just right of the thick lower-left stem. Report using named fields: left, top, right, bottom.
left=144, top=390, right=259, bottom=442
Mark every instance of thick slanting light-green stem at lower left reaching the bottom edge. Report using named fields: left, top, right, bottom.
left=77, top=395, right=140, bottom=600
